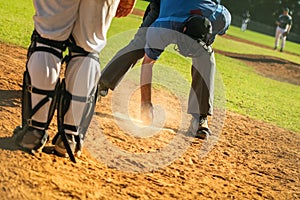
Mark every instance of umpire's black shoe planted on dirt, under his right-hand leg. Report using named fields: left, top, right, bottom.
left=189, top=115, right=212, bottom=139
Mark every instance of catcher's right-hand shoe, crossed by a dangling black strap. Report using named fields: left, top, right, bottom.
left=54, top=134, right=81, bottom=157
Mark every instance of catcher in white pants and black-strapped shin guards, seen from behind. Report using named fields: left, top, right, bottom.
left=14, top=0, right=135, bottom=160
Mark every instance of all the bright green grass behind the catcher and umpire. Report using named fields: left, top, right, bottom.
left=0, top=0, right=300, bottom=132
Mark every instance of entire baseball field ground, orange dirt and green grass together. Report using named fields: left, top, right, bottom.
left=0, top=0, right=300, bottom=199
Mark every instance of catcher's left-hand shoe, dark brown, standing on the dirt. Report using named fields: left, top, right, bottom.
left=14, top=126, right=49, bottom=153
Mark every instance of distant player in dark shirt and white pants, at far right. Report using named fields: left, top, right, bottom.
left=274, top=8, right=292, bottom=52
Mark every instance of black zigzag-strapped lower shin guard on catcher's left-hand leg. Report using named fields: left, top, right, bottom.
left=22, top=70, right=59, bottom=129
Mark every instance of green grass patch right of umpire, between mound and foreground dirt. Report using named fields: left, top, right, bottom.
left=216, top=55, right=300, bottom=132
